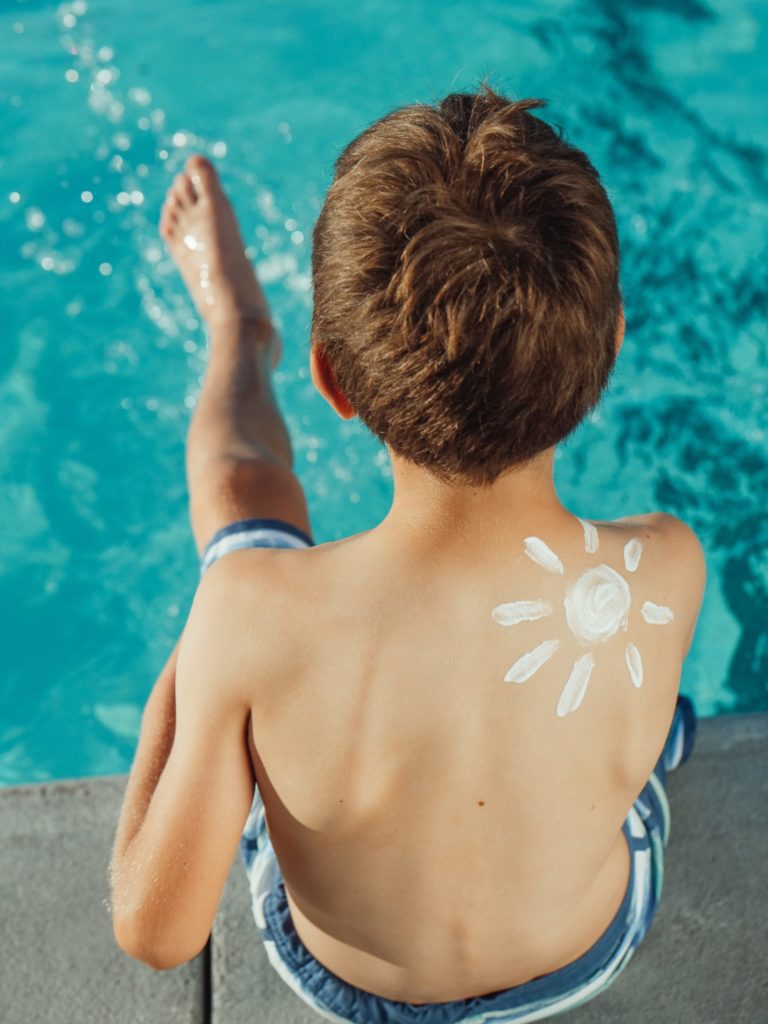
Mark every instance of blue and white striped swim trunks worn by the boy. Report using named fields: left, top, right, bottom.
left=201, top=519, right=696, bottom=1024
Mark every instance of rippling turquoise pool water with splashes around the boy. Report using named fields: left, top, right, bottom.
left=0, top=0, right=768, bottom=784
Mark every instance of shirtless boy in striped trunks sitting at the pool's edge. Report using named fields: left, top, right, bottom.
left=112, top=87, right=705, bottom=1024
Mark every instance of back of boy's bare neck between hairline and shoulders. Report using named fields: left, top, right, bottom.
left=379, top=449, right=570, bottom=547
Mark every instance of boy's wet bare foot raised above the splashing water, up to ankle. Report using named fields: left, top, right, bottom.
left=160, top=155, right=282, bottom=367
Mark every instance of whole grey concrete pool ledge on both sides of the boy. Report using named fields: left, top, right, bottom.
left=0, top=714, right=768, bottom=1024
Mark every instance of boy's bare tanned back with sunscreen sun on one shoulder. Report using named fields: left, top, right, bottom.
left=214, top=508, right=705, bottom=1002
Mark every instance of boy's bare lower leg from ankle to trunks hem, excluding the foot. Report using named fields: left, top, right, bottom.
left=186, top=317, right=311, bottom=555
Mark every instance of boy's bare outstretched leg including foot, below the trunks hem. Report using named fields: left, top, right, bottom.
left=160, top=149, right=309, bottom=554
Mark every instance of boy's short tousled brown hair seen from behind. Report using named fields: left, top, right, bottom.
left=311, top=85, right=622, bottom=485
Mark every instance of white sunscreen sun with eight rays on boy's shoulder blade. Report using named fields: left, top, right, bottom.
left=490, top=519, right=675, bottom=718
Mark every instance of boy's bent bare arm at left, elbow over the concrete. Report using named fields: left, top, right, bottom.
left=110, top=559, right=255, bottom=970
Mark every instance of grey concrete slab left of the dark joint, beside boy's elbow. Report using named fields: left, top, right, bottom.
left=0, top=776, right=206, bottom=1024
